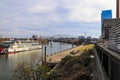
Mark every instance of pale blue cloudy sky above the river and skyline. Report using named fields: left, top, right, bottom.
left=0, top=0, right=116, bottom=38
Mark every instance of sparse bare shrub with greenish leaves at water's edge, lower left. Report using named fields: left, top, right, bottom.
left=14, top=55, right=49, bottom=80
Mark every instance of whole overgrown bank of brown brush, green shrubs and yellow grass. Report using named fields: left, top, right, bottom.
left=14, top=44, right=95, bottom=80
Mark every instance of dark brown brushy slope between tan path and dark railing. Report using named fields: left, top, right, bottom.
left=48, top=50, right=96, bottom=80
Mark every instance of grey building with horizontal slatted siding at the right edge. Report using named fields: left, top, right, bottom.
left=108, top=18, right=120, bottom=52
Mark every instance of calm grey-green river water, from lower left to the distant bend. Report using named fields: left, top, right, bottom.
left=0, top=42, right=72, bottom=80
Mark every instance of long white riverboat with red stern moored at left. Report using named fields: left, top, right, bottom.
left=0, top=40, right=41, bottom=54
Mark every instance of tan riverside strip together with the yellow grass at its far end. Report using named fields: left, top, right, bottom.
left=46, top=45, right=93, bottom=63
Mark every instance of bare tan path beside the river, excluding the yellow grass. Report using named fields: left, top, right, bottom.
left=46, top=45, right=83, bottom=63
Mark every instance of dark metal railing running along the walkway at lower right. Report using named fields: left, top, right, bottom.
left=95, top=45, right=120, bottom=80
